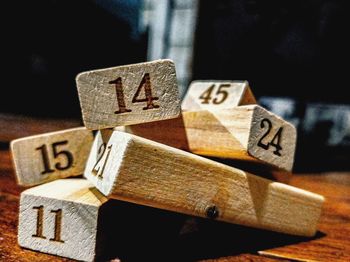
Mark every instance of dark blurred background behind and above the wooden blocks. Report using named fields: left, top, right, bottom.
left=0, top=0, right=350, bottom=172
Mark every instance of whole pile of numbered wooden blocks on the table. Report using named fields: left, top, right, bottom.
left=11, top=60, right=324, bottom=261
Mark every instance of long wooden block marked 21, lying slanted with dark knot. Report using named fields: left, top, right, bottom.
left=84, top=130, right=324, bottom=236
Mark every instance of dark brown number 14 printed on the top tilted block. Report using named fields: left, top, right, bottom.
left=109, top=73, right=159, bottom=114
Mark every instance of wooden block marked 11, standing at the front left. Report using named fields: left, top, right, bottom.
left=18, top=179, right=107, bottom=261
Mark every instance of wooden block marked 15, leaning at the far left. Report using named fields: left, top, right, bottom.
left=11, top=127, right=94, bottom=186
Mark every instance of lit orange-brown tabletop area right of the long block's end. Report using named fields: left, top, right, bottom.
left=259, top=172, right=350, bottom=262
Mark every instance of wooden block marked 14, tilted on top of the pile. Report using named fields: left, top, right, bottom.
left=76, top=59, right=180, bottom=129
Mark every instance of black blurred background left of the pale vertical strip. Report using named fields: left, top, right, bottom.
left=0, top=0, right=147, bottom=118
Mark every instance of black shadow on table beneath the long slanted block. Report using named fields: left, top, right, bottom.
left=95, top=200, right=324, bottom=261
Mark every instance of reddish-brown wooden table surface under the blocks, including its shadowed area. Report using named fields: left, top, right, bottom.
left=0, top=115, right=350, bottom=262
